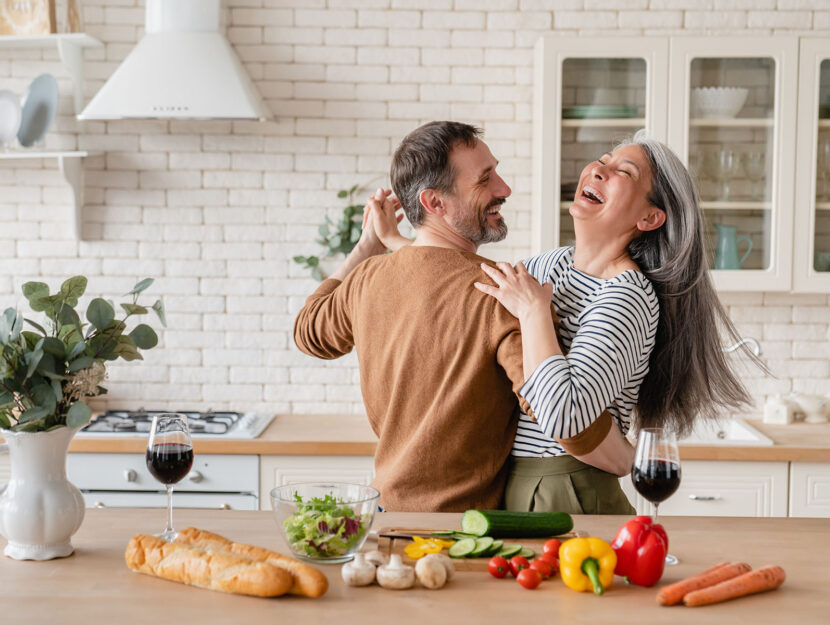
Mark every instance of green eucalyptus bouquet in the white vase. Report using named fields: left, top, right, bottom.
left=0, top=276, right=167, bottom=432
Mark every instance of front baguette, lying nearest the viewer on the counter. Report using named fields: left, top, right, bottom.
left=124, top=534, right=293, bottom=597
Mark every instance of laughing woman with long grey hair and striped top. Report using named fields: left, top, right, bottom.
left=370, top=132, right=760, bottom=514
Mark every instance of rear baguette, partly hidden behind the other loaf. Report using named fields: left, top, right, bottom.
left=176, top=527, right=329, bottom=597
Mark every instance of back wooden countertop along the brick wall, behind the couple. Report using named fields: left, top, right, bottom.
left=63, top=415, right=830, bottom=462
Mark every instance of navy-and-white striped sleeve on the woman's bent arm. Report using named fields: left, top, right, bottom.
left=520, top=283, right=657, bottom=439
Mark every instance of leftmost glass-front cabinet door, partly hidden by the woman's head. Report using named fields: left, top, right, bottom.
left=531, top=36, right=668, bottom=253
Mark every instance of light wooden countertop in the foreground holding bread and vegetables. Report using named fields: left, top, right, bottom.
left=0, top=509, right=830, bottom=625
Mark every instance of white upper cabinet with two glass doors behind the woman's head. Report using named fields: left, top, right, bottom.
left=532, top=35, right=812, bottom=291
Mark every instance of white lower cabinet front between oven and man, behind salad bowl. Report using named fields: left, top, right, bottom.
left=259, top=456, right=375, bottom=510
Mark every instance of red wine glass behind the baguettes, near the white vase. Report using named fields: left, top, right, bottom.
left=147, top=412, right=193, bottom=541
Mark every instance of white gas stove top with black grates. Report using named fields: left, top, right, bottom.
left=77, top=408, right=274, bottom=439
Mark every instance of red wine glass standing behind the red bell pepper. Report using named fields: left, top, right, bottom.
left=631, top=428, right=680, bottom=564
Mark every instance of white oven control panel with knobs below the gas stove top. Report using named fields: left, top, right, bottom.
left=66, top=453, right=259, bottom=493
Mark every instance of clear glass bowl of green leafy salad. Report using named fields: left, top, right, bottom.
left=271, top=482, right=380, bottom=564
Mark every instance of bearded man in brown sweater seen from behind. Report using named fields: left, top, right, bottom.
left=294, top=122, right=604, bottom=512
